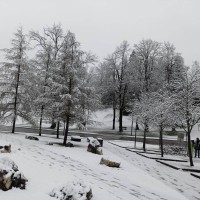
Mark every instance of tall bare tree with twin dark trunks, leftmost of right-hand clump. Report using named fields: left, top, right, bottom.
left=100, top=41, right=130, bottom=132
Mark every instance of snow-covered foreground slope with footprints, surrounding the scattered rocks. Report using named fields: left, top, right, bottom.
left=0, top=133, right=199, bottom=200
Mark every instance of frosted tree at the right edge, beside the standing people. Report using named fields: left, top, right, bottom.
left=171, top=62, right=200, bottom=166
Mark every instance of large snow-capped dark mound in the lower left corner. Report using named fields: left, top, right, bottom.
left=0, top=158, right=27, bottom=191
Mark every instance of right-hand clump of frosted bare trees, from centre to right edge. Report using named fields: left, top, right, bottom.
left=97, top=39, right=200, bottom=166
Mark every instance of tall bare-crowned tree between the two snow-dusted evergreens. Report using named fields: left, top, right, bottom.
left=30, top=25, right=64, bottom=136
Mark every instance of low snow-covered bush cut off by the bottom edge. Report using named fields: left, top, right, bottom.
left=50, top=180, right=93, bottom=200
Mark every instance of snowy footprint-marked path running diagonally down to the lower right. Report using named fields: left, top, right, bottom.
left=107, top=144, right=200, bottom=200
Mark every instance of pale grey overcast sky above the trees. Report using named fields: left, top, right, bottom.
left=0, top=0, right=200, bottom=65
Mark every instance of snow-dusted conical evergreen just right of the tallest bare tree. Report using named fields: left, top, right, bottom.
left=52, top=32, right=95, bottom=145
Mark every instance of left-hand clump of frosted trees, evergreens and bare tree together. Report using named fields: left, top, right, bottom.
left=0, top=25, right=99, bottom=145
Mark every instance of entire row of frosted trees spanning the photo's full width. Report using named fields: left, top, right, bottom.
left=0, top=24, right=200, bottom=166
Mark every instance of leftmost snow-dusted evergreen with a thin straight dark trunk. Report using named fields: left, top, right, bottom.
left=1, top=28, right=31, bottom=133
